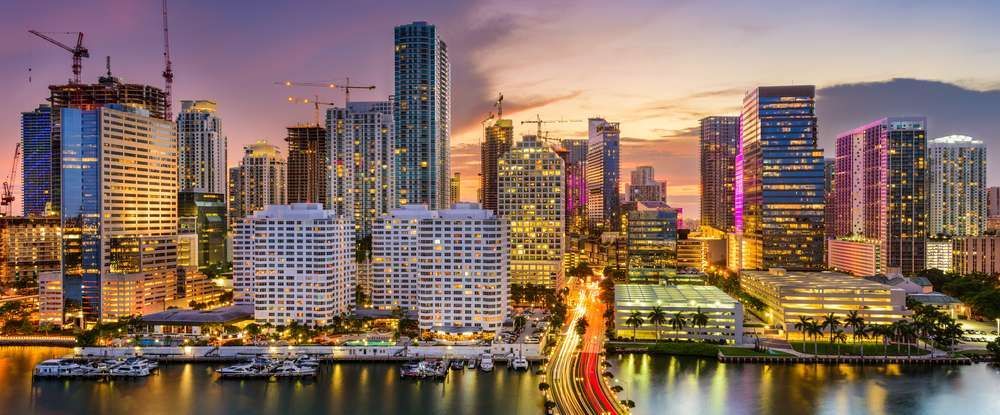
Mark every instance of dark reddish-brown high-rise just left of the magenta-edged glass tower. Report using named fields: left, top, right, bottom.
left=699, top=116, right=740, bottom=232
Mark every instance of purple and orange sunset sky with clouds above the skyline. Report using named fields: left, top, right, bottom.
left=0, top=0, right=1000, bottom=218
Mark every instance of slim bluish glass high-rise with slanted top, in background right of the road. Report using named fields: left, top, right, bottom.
left=586, top=118, right=621, bottom=231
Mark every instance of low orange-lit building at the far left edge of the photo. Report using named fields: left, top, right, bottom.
left=0, top=216, right=62, bottom=287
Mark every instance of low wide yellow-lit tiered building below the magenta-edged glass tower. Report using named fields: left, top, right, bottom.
left=740, top=268, right=913, bottom=331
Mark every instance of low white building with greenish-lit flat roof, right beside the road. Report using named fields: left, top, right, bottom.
left=615, top=284, right=743, bottom=344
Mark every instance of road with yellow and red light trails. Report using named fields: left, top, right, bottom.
left=548, top=285, right=627, bottom=415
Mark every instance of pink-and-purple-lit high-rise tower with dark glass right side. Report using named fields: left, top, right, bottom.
left=831, top=117, right=927, bottom=275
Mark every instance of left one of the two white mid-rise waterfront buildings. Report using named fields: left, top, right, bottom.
left=233, top=203, right=356, bottom=326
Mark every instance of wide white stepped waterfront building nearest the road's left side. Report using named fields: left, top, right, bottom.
left=372, top=203, right=510, bottom=336
